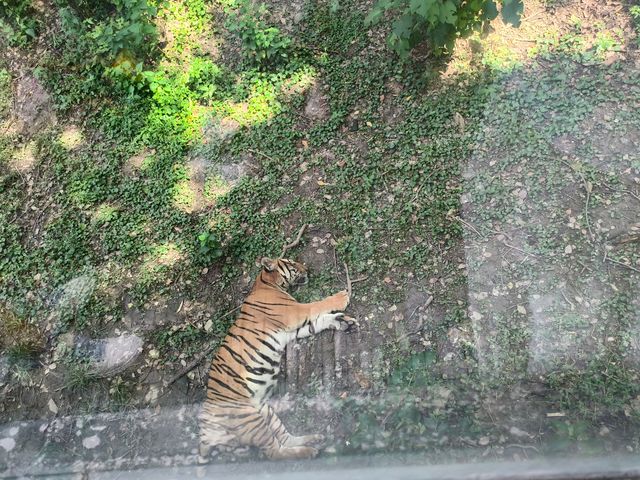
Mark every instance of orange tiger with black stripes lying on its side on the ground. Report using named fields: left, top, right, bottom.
left=199, top=257, right=356, bottom=462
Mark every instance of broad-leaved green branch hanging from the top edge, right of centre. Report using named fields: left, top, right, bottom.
left=365, top=0, right=523, bottom=58
